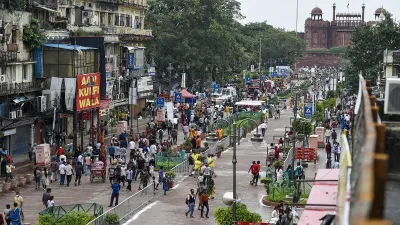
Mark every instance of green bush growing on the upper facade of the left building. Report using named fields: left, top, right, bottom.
left=22, top=20, right=47, bottom=50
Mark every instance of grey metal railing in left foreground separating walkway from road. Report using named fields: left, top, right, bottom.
left=87, top=182, right=162, bottom=225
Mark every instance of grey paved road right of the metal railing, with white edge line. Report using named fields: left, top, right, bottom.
left=125, top=101, right=328, bottom=225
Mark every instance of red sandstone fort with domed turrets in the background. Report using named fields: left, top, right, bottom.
left=297, top=4, right=384, bottom=68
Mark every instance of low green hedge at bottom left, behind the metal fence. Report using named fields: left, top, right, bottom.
left=37, top=212, right=95, bottom=225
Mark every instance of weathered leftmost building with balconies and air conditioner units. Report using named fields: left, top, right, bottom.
left=0, top=9, right=41, bottom=155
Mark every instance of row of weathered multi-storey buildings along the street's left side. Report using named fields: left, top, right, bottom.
left=0, top=0, right=152, bottom=156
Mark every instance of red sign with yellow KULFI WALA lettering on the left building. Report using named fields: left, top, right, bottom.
left=76, top=73, right=100, bottom=111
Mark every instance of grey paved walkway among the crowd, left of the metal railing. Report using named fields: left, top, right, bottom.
left=0, top=117, right=183, bottom=224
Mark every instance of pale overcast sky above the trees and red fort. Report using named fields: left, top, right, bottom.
left=238, top=0, right=400, bottom=32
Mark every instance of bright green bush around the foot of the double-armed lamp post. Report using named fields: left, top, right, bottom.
left=214, top=204, right=262, bottom=225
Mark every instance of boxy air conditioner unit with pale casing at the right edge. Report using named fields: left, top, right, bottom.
left=384, top=77, right=400, bottom=115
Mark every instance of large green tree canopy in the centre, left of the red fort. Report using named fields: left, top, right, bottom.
left=146, top=0, right=305, bottom=86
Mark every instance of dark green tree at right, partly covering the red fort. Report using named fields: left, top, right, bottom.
left=344, top=12, right=400, bottom=93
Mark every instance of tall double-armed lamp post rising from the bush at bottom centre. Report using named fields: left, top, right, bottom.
left=206, top=118, right=263, bottom=224
